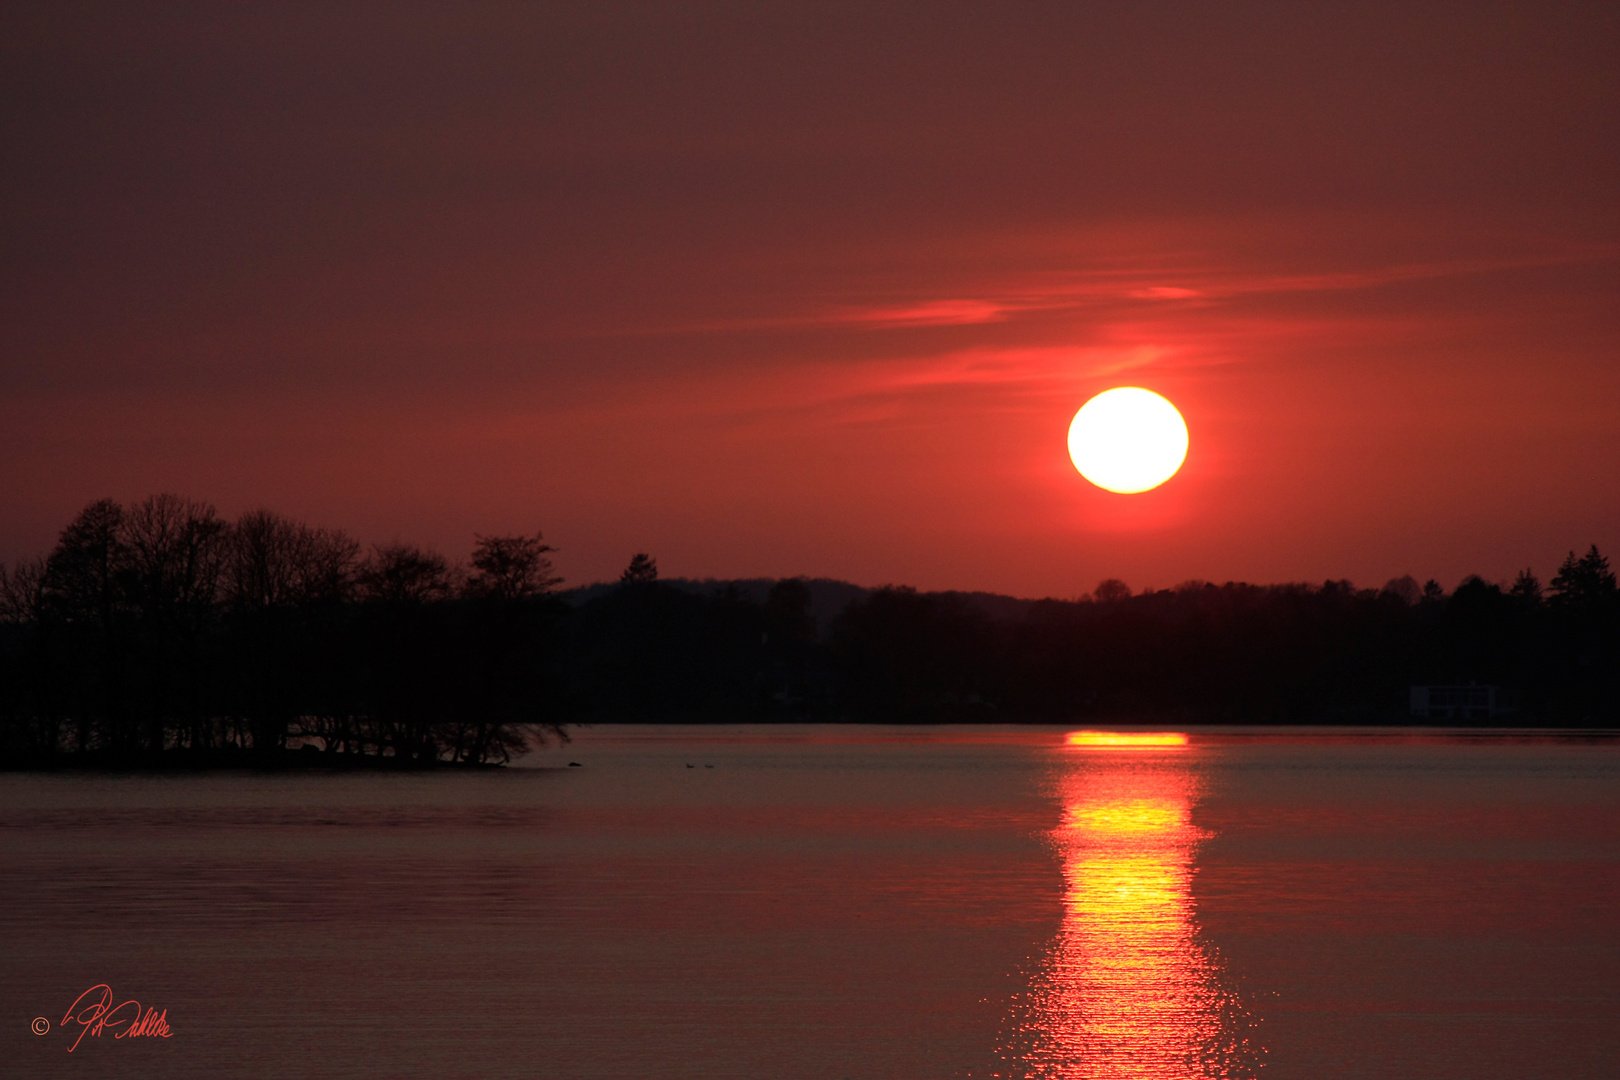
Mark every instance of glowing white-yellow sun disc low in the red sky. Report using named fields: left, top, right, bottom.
left=1069, top=387, right=1187, bottom=495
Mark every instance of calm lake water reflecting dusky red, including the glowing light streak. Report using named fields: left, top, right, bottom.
left=0, top=725, right=1620, bottom=1080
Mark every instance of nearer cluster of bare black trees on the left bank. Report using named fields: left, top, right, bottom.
left=0, top=495, right=562, bottom=764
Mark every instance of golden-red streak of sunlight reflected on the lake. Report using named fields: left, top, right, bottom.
left=1003, top=732, right=1264, bottom=1080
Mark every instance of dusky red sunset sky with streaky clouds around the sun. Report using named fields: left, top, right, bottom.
left=0, top=2, right=1620, bottom=596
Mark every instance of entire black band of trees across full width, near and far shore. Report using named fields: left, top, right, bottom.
left=0, top=495, right=1620, bottom=764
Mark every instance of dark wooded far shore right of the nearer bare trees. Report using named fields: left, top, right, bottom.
left=564, top=547, right=1620, bottom=725
